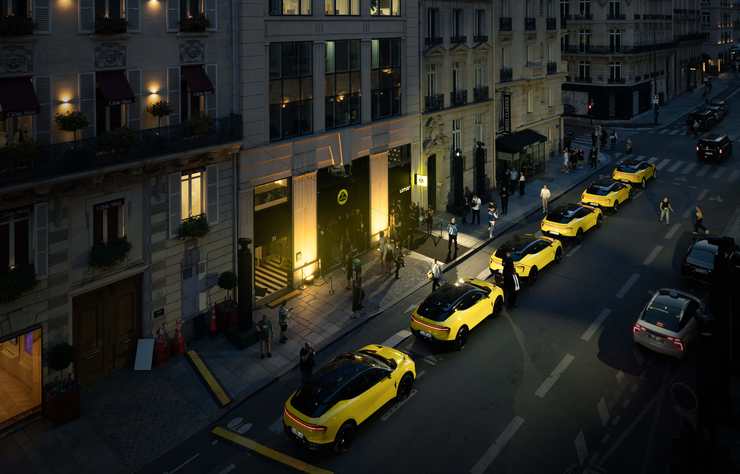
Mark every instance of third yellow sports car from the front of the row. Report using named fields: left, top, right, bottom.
left=488, top=234, right=563, bottom=281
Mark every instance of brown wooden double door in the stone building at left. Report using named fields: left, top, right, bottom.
left=73, top=276, right=141, bottom=384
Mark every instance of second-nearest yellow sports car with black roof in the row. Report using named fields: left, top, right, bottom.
left=411, top=278, right=504, bottom=349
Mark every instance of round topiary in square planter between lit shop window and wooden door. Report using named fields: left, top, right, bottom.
left=44, top=342, right=80, bottom=424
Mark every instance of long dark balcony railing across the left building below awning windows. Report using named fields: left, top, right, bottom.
left=0, top=114, right=242, bottom=187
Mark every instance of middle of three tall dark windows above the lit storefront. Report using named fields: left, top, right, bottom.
left=326, top=40, right=362, bottom=128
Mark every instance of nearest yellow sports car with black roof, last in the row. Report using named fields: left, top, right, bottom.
left=283, top=344, right=416, bottom=452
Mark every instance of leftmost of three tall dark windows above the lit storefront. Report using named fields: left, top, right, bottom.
left=270, top=41, right=313, bottom=140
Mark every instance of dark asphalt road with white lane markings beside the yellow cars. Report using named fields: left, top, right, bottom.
left=143, top=84, right=740, bottom=474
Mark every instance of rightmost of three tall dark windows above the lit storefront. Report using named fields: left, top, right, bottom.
left=371, top=38, right=401, bottom=120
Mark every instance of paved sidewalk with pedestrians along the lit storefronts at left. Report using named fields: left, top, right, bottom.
left=0, top=149, right=620, bottom=474
